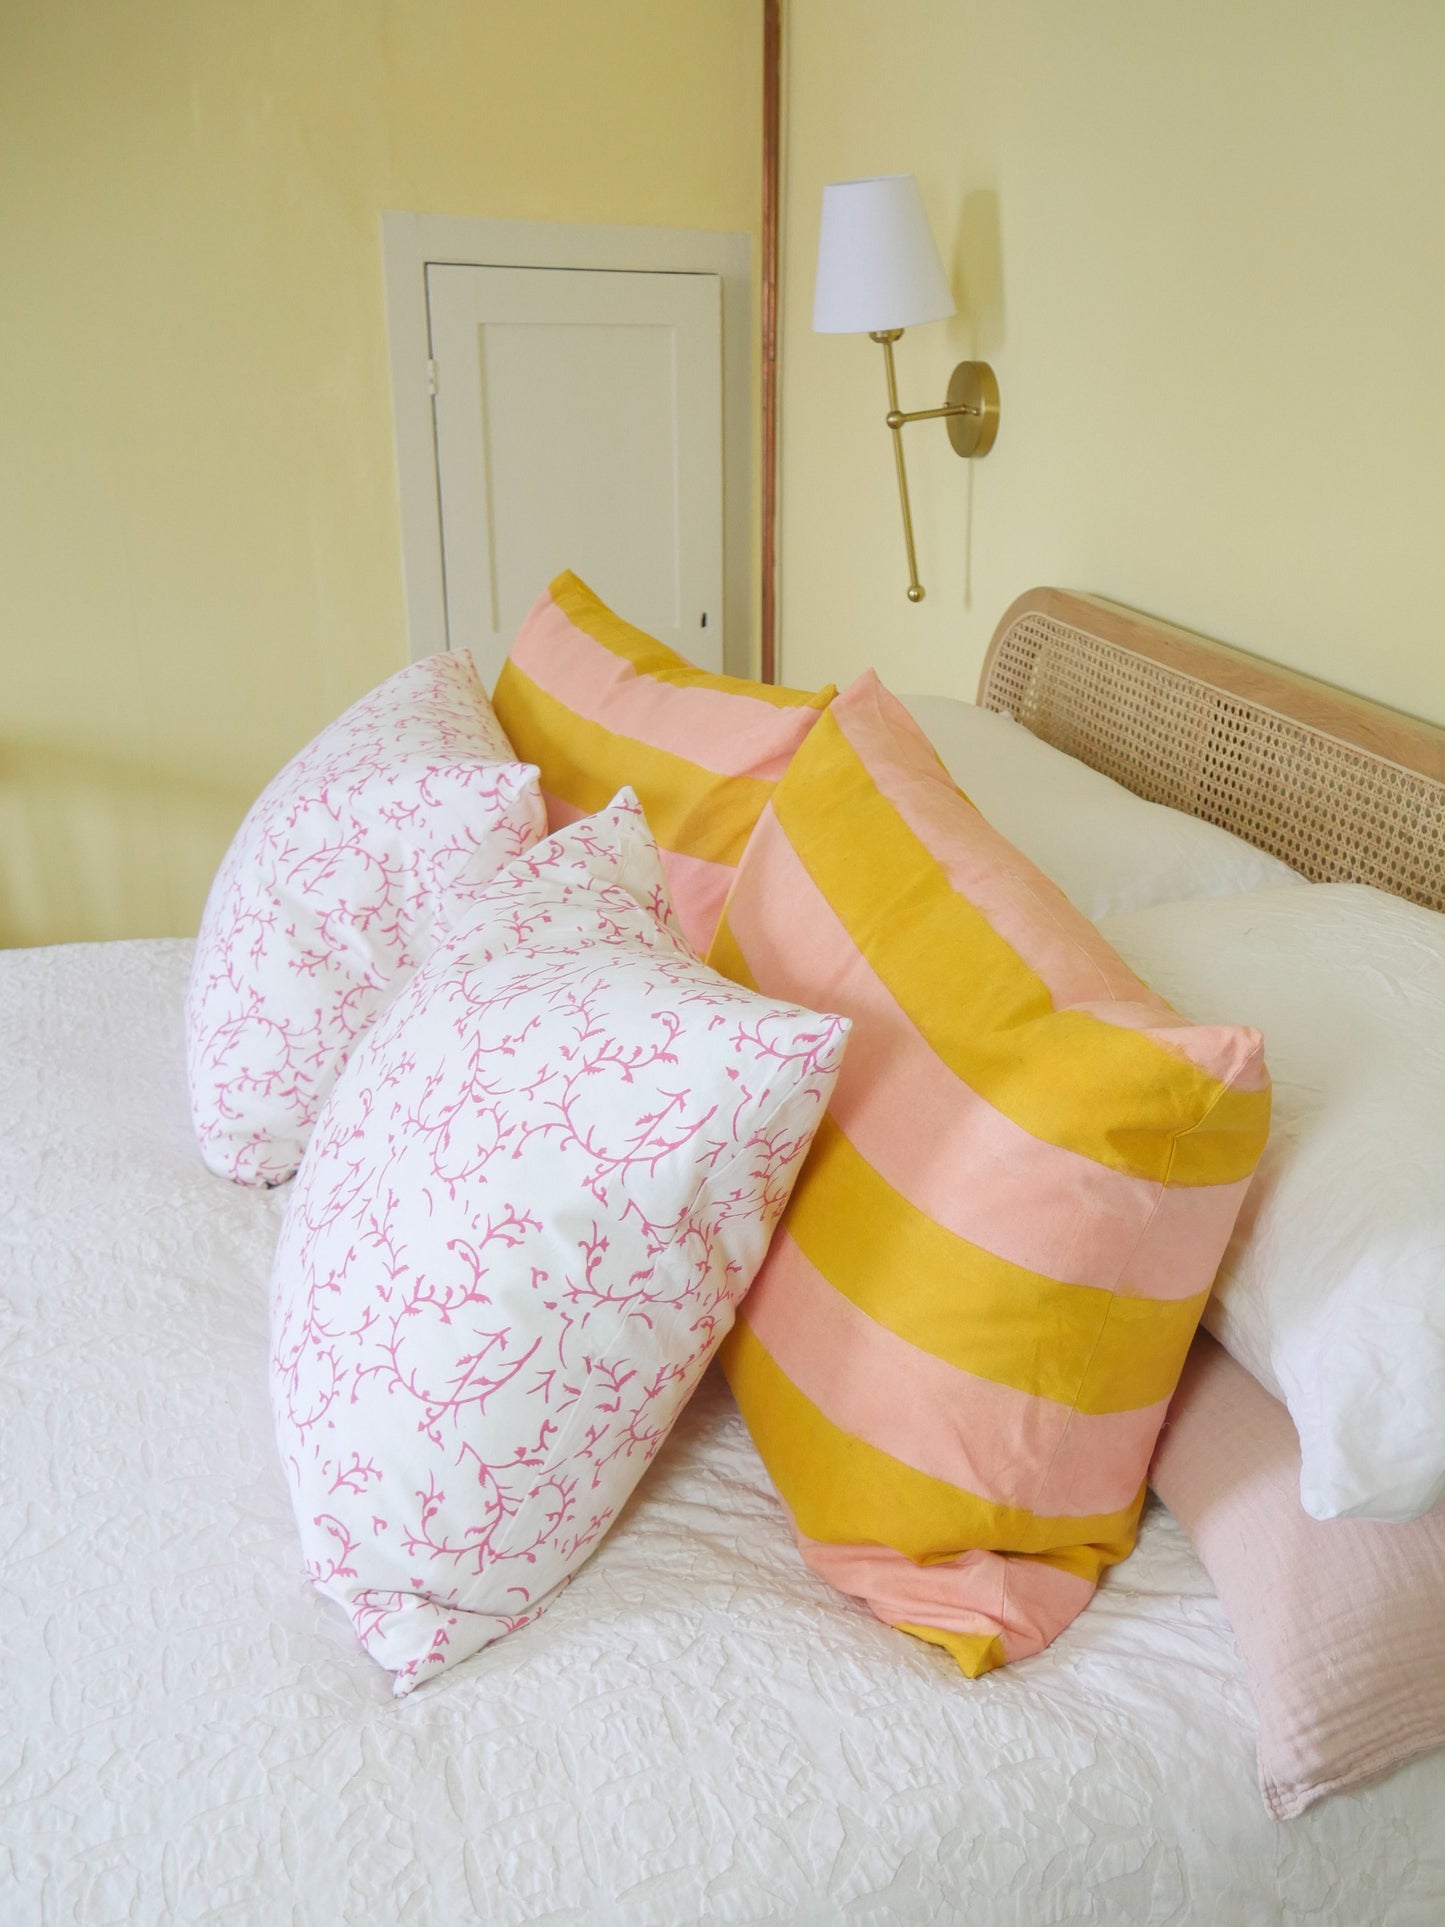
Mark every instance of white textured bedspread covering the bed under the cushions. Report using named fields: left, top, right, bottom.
left=0, top=942, right=1445, bottom=1927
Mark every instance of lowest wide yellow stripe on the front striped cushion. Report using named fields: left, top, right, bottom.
left=721, top=1305, right=1144, bottom=1567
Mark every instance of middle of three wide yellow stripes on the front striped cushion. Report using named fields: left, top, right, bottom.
left=784, top=1116, right=1208, bottom=1412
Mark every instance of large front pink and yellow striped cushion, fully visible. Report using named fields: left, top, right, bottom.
left=709, top=674, right=1270, bottom=1675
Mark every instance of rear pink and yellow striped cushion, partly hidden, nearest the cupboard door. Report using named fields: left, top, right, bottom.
left=491, top=572, right=836, bottom=956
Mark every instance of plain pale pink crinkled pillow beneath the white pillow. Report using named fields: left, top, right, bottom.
left=1150, top=1332, right=1445, bottom=1819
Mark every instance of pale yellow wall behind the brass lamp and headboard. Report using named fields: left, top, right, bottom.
left=782, top=0, right=1445, bottom=721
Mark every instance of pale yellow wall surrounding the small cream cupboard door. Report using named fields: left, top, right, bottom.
left=0, top=0, right=761, bottom=942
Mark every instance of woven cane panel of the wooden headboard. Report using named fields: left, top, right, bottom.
left=983, top=613, right=1445, bottom=910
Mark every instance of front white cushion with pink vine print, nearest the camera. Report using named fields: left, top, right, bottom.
left=272, top=790, right=848, bottom=1694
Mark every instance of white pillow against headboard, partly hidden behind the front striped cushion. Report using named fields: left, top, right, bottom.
left=904, top=696, right=1304, bottom=919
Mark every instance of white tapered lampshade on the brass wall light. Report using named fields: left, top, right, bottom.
left=813, top=173, right=954, bottom=335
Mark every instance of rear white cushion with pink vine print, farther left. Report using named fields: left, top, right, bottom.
left=185, top=655, right=547, bottom=1185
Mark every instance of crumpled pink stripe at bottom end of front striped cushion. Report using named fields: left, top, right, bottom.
left=794, top=1528, right=1094, bottom=1661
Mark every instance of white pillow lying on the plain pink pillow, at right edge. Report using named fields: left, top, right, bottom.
left=1100, top=883, right=1445, bottom=1520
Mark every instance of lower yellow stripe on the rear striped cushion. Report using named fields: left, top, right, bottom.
left=491, top=661, right=776, bottom=867
